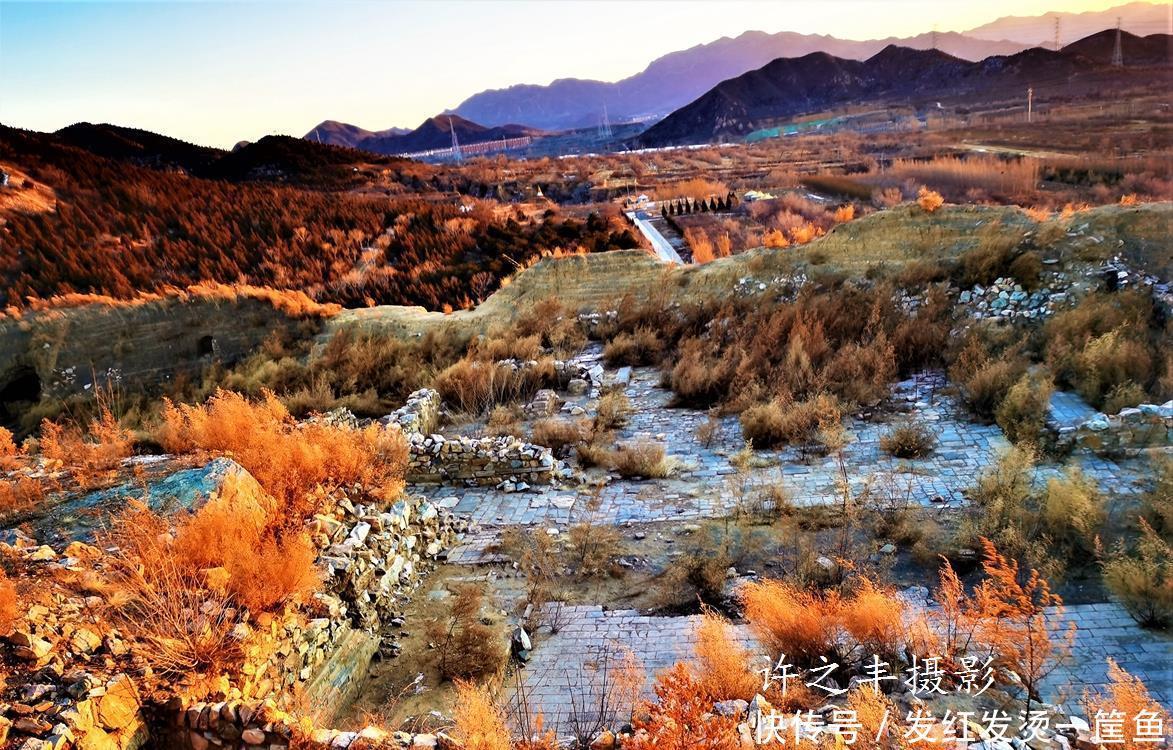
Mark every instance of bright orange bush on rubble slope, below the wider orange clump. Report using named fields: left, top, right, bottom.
left=172, top=475, right=319, bottom=612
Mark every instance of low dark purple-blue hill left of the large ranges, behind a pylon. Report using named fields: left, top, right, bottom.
left=304, top=114, right=541, bottom=155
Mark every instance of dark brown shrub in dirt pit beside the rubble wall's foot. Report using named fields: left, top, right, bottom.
left=428, top=583, right=508, bottom=680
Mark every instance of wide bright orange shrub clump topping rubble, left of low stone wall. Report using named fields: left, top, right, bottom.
left=158, top=391, right=407, bottom=528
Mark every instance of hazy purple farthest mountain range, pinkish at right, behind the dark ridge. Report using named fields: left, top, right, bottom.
left=305, top=2, right=1168, bottom=154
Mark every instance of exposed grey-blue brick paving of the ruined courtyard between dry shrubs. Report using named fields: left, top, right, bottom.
left=412, top=346, right=1173, bottom=713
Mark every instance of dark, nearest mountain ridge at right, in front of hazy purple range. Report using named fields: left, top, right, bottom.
left=635, top=29, right=1169, bottom=147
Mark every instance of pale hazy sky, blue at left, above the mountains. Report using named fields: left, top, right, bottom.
left=0, top=0, right=1130, bottom=147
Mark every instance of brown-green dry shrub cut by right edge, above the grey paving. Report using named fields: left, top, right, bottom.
left=1104, top=519, right=1173, bottom=628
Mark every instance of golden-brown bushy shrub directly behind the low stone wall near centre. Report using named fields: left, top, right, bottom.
left=432, top=359, right=557, bottom=414
